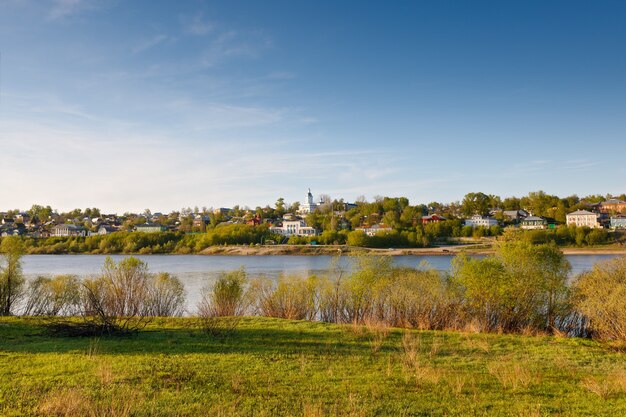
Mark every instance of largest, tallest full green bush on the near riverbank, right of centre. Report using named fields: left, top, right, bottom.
left=453, top=242, right=575, bottom=332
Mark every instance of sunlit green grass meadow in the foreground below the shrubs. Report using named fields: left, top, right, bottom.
left=0, top=318, right=626, bottom=416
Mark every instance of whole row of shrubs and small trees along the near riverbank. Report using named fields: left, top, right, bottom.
left=0, top=239, right=626, bottom=342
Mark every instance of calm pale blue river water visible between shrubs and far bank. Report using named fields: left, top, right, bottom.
left=22, top=255, right=616, bottom=309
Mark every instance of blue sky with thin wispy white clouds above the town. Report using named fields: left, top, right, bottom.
left=0, top=0, right=626, bottom=213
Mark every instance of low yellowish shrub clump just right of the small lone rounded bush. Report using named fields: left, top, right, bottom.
left=251, top=276, right=319, bottom=320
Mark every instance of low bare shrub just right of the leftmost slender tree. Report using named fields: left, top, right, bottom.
left=24, top=275, right=80, bottom=316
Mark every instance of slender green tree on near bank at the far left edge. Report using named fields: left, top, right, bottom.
left=0, top=237, right=24, bottom=316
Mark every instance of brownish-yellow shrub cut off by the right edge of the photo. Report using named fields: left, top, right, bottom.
left=574, top=257, right=626, bottom=342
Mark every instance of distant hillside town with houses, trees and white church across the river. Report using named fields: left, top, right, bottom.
left=0, top=189, right=626, bottom=249
